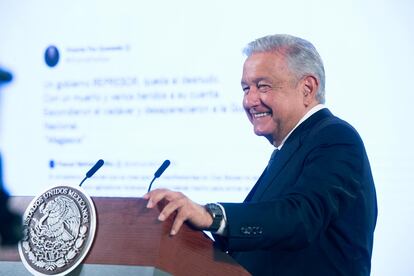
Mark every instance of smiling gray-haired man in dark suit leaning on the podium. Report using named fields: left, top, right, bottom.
left=144, top=35, right=377, bottom=275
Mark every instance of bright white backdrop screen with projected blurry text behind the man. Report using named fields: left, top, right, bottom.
left=0, top=0, right=414, bottom=275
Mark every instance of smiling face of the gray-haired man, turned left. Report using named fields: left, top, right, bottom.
left=241, top=52, right=306, bottom=146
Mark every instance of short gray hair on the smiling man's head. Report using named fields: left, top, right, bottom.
left=243, top=34, right=325, bottom=103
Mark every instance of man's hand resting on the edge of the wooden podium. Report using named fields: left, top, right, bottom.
left=143, top=189, right=213, bottom=236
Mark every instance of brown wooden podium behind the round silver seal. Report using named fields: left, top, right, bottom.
left=0, top=197, right=250, bottom=275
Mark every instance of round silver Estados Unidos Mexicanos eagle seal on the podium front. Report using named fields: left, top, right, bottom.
left=19, top=186, right=96, bottom=275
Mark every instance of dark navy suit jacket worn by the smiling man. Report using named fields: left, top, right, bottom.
left=216, top=109, right=377, bottom=276
